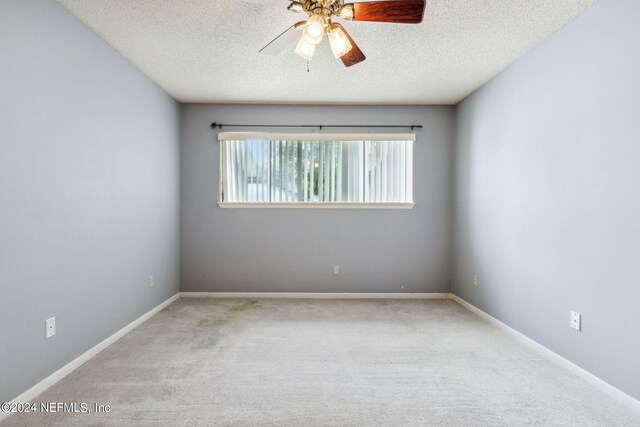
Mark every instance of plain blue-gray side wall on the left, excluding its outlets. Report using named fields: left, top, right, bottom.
left=0, top=0, right=179, bottom=402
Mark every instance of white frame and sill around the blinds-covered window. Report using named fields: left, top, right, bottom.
left=218, top=132, right=416, bottom=209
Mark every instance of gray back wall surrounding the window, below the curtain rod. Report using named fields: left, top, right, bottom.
left=181, top=105, right=453, bottom=292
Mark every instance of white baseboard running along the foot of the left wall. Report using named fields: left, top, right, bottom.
left=0, top=293, right=180, bottom=421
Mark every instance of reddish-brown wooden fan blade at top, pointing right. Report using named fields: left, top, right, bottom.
left=353, top=0, right=425, bottom=24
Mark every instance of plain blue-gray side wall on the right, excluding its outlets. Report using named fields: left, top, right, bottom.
left=452, top=0, right=640, bottom=398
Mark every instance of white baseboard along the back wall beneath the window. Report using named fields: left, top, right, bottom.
left=180, top=292, right=449, bottom=299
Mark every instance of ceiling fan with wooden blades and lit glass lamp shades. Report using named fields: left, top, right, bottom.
left=259, top=0, right=425, bottom=71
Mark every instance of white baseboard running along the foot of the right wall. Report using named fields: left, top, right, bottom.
left=449, top=294, right=640, bottom=412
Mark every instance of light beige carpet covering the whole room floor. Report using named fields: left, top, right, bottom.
left=2, top=299, right=640, bottom=427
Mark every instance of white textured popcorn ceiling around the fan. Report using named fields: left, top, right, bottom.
left=60, top=0, right=596, bottom=104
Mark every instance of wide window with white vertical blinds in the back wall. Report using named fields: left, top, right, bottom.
left=218, top=132, right=415, bottom=208
